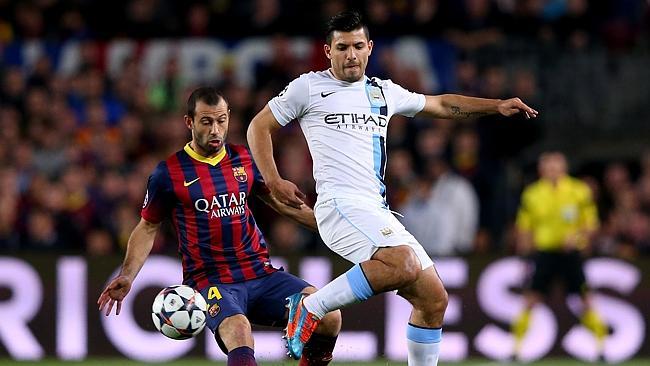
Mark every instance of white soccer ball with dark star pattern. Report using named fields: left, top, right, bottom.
left=151, top=285, right=208, bottom=339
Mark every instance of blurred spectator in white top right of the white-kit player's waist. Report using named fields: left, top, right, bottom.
left=401, top=156, right=479, bottom=257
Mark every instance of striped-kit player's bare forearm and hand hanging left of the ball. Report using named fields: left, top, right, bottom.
left=97, top=219, right=160, bottom=316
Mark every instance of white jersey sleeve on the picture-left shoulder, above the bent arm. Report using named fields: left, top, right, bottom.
left=269, top=74, right=309, bottom=126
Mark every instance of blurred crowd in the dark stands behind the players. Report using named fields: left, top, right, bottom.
left=0, top=0, right=650, bottom=259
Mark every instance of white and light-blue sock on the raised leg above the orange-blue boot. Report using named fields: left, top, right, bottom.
left=303, top=264, right=373, bottom=319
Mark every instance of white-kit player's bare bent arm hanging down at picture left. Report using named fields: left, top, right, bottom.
left=246, top=105, right=305, bottom=209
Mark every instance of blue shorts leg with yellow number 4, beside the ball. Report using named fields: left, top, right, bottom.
left=200, top=282, right=248, bottom=344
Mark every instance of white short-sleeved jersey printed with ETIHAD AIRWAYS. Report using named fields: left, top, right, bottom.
left=269, top=70, right=425, bottom=205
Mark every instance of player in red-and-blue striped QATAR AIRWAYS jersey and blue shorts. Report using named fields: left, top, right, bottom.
left=97, top=87, right=341, bottom=366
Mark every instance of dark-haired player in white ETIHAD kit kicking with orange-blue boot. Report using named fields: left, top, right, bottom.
left=247, top=11, right=537, bottom=366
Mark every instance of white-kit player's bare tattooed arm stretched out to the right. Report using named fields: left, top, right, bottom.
left=420, top=94, right=538, bottom=119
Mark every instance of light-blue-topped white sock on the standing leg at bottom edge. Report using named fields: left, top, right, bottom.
left=406, top=323, right=442, bottom=366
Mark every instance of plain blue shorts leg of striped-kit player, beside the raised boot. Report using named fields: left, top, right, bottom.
left=248, top=271, right=312, bottom=326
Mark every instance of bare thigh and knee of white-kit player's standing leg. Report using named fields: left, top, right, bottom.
left=397, top=266, right=448, bottom=312
